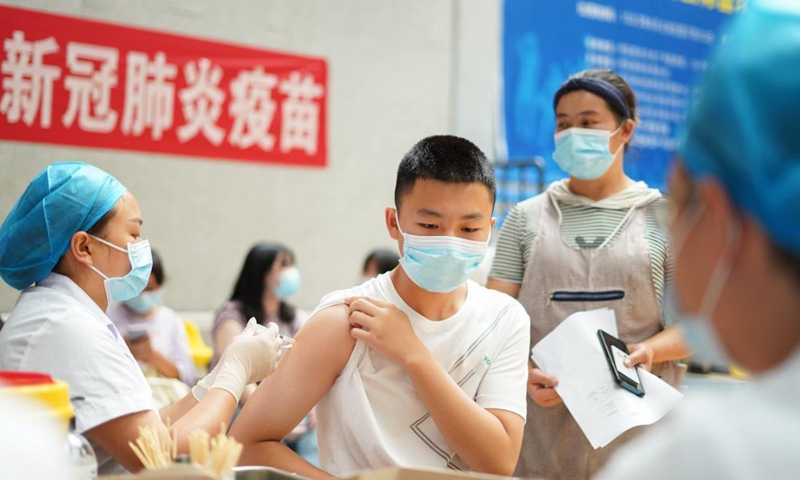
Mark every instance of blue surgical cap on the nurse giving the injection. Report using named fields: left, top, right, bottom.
left=0, top=162, right=126, bottom=290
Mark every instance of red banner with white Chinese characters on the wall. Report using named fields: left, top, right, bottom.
left=0, top=6, right=327, bottom=167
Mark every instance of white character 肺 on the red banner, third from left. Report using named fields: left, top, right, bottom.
left=121, top=52, right=178, bottom=140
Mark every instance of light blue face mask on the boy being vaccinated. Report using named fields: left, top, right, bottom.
left=395, top=213, right=491, bottom=293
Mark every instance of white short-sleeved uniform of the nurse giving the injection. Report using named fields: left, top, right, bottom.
left=0, top=273, right=158, bottom=474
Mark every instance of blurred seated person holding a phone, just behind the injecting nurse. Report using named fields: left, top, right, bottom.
left=107, top=250, right=197, bottom=385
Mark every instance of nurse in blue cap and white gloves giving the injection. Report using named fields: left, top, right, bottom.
left=0, top=162, right=280, bottom=473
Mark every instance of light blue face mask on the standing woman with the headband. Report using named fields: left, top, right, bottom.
left=553, top=125, right=625, bottom=180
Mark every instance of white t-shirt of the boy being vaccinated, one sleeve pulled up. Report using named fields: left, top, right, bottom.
left=312, top=273, right=530, bottom=476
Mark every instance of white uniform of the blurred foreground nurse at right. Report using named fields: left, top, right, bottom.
left=597, top=351, right=800, bottom=480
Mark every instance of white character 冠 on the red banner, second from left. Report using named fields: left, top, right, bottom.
left=61, top=42, right=119, bottom=133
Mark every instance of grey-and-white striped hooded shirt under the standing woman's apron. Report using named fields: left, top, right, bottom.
left=489, top=193, right=672, bottom=304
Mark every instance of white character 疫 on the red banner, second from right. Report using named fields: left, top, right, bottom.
left=228, top=67, right=278, bottom=151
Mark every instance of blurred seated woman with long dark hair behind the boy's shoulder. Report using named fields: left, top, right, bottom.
left=211, top=242, right=317, bottom=465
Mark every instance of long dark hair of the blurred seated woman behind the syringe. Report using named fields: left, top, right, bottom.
left=230, top=242, right=295, bottom=324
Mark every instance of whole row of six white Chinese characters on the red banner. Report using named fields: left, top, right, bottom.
left=0, top=30, right=325, bottom=158
